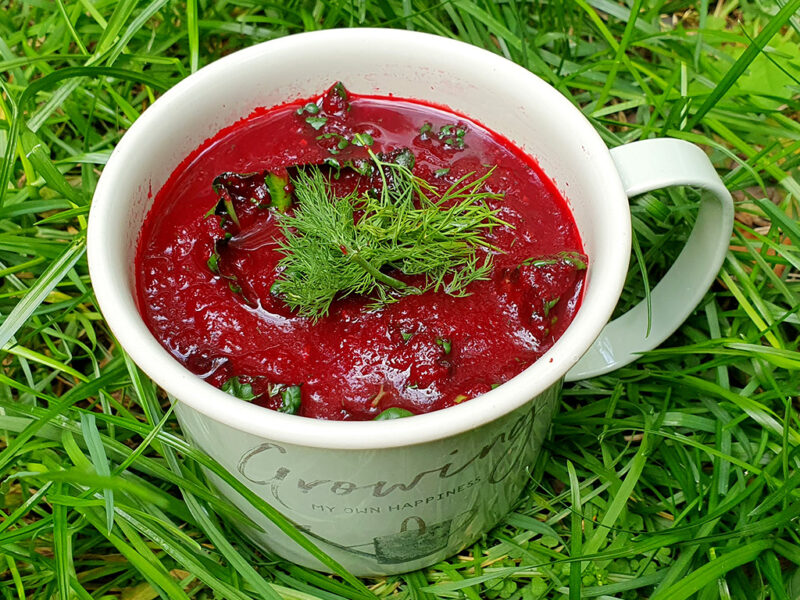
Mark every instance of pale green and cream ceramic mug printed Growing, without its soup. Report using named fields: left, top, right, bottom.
left=89, top=29, right=733, bottom=575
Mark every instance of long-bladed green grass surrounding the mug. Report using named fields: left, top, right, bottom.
left=0, top=0, right=800, bottom=600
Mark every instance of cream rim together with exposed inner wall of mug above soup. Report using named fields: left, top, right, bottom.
left=89, top=29, right=630, bottom=448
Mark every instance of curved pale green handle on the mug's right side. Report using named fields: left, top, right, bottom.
left=565, top=138, right=733, bottom=381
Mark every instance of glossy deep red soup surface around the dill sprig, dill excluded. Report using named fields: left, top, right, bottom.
left=136, top=83, right=585, bottom=420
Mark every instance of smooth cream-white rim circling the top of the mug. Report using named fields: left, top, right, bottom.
left=87, top=28, right=630, bottom=450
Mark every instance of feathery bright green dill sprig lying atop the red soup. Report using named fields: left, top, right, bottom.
left=272, top=151, right=506, bottom=320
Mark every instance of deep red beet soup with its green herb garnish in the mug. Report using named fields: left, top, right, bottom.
left=136, top=84, right=586, bottom=420
